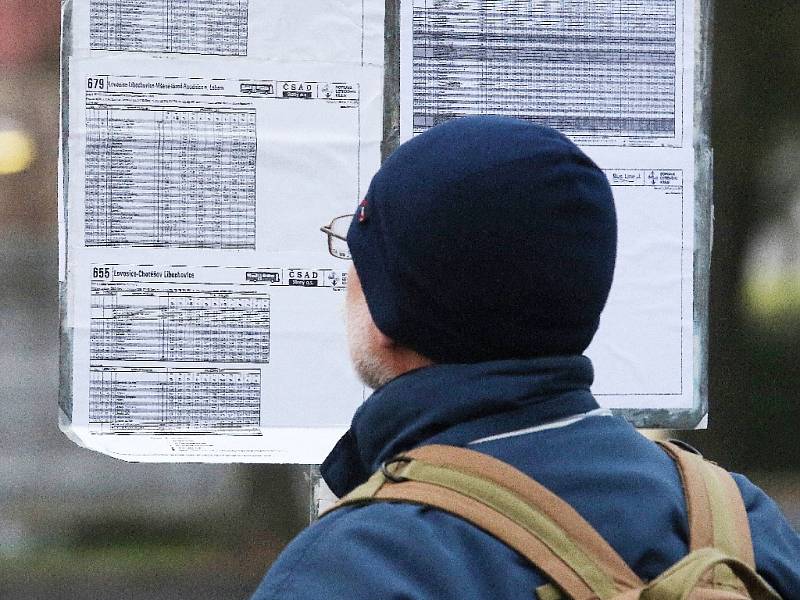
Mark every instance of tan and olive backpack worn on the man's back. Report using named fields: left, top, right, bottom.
left=323, top=442, right=781, bottom=600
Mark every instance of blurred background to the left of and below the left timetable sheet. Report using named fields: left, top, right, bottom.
left=0, top=0, right=308, bottom=600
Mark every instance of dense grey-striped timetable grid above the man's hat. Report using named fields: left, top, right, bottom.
left=413, top=0, right=681, bottom=138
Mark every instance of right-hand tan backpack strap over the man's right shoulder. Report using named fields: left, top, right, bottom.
left=659, top=442, right=756, bottom=587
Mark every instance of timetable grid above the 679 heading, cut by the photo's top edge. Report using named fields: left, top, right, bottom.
left=89, top=0, right=249, bottom=56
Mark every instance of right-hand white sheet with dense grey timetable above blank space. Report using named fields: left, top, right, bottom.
left=400, top=0, right=698, bottom=411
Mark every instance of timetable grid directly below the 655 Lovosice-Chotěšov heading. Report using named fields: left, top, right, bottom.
left=89, top=288, right=270, bottom=363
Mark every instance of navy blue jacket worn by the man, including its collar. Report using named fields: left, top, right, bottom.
left=253, top=356, right=800, bottom=600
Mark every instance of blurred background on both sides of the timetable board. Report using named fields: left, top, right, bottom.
left=0, top=0, right=800, bottom=600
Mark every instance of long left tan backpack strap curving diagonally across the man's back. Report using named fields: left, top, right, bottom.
left=324, top=446, right=643, bottom=600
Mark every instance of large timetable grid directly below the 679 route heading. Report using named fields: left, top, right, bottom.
left=84, top=104, right=257, bottom=249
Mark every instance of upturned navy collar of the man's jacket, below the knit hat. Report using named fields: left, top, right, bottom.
left=321, top=356, right=598, bottom=496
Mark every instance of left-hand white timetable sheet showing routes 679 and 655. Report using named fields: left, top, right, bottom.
left=61, top=0, right=384, bottom=463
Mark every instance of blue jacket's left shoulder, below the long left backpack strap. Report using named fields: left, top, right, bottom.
left=252, top=502, right=543, bottom=600
